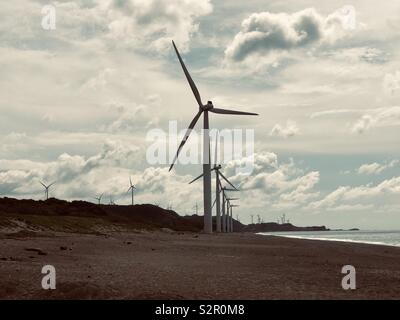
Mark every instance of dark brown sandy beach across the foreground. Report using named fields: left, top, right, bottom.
left=0, top=231, right=400, bottom=299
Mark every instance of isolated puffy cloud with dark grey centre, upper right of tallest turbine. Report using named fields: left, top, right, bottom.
left=225, top=6, right=356, bottom=61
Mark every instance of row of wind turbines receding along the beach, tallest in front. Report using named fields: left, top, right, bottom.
left=169, top=41, right=258, bottom=233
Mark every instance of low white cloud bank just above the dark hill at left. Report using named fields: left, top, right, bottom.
left=0, top=141, right=201, bottom=212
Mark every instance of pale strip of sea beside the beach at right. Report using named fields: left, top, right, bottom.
left=259, top=231, right=400, bottom=247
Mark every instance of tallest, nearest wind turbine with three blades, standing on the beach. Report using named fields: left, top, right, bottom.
left=169, top=41, right=258, bottom=233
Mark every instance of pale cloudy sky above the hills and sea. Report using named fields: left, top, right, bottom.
left=0, top=0, right=400, bottom=229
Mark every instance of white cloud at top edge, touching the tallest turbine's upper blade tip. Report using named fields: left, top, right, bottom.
left=99, top=0, right=212, bottom=52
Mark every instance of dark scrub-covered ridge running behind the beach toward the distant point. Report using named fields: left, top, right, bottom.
left=0, top=198, right=358, bottom=233
